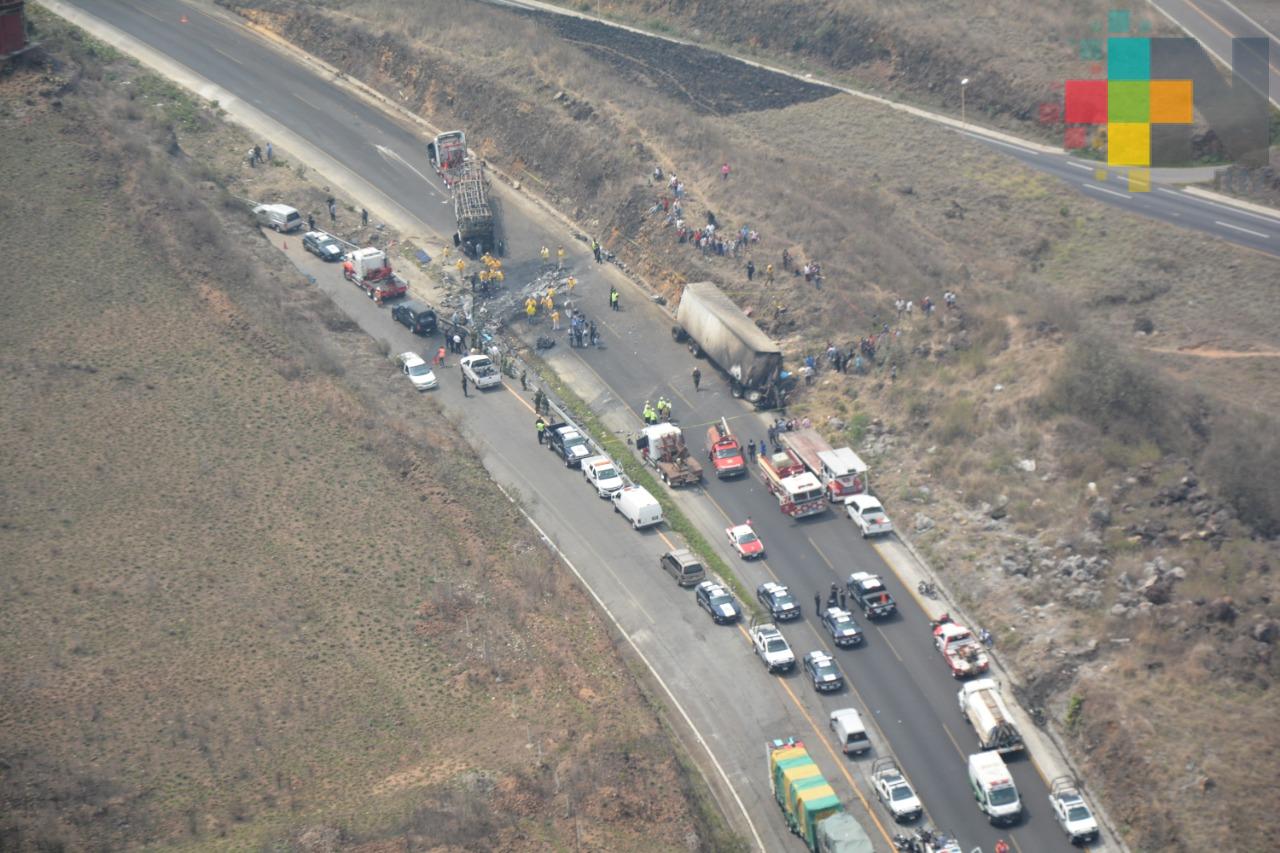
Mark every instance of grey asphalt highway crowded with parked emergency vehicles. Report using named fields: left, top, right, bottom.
left=55, top=0, right=1111, bottom=853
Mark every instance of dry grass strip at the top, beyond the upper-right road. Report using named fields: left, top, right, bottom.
left=559, top=0, right=1181, bottom=138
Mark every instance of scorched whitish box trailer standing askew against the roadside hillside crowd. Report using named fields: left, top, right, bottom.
left=671, top=282, right=786, bottom=409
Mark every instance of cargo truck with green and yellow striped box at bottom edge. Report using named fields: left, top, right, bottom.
left=765, top=738, right=874, bottom=853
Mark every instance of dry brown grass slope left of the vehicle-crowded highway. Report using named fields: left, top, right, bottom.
left=0, top=15, right=719, bottom=852
